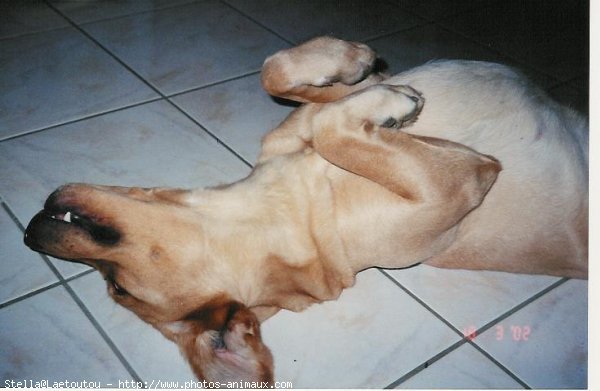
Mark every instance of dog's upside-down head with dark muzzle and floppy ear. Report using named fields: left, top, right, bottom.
left=25, top=184, right=272, bottom=381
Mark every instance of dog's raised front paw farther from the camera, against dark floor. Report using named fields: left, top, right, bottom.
left=262, top=37, right=385, bottom=103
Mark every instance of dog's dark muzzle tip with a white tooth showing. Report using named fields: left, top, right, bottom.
left=24, top=192, right=121, bottom=259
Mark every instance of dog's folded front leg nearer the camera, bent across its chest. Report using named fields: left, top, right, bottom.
left=312, top=85, right=500, bottom=226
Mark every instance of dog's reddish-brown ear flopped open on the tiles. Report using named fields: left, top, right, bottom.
left=159, top=301, right=273, bottom=386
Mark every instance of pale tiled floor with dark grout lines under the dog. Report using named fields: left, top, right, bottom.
left=0, top=0, right=588, bottom=388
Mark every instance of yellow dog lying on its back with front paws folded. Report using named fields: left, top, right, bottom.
left=25, top=37, right=588, bottom=384
